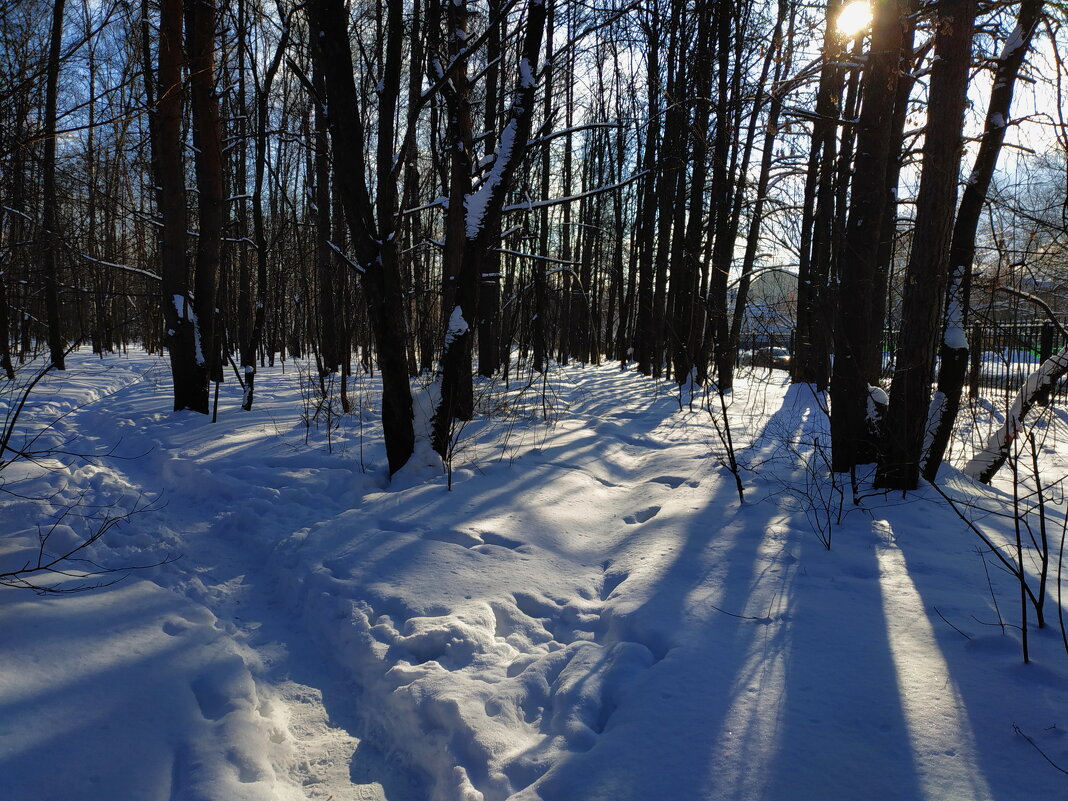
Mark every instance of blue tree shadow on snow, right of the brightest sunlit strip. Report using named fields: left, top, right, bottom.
left=875, top=491, right=1068, bottom=801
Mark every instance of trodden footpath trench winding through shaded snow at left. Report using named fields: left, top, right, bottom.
left=50, top=356, right=420, bottom=801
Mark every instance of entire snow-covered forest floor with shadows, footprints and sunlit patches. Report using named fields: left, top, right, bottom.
left=0, top=352, right=1068, bottom=801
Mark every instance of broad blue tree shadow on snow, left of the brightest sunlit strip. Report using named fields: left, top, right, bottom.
left=531, top=388, right=922, bottom=801
